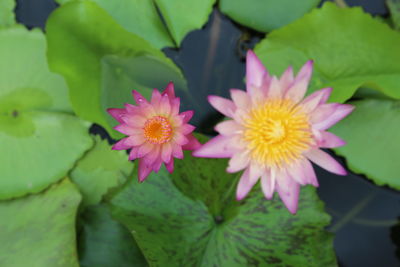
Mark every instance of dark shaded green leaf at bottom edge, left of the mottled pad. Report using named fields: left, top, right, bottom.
left=79, top=204, right=147, bottom=267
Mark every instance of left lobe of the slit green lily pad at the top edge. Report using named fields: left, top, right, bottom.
left=56, top=0, right=174, bottom=48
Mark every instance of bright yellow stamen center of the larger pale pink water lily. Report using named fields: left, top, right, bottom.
left=244, top=100, right=313, bottom=167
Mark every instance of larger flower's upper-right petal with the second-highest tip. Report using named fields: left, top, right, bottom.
left=285, top=60, right=313, bottom=103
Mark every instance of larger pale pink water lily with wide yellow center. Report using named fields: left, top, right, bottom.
left=193, top=51, right=353, bottom=213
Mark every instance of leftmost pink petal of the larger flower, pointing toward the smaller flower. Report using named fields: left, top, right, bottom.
left=193, top=135, right=234, bottom=158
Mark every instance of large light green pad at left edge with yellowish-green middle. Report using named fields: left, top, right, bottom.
left=0, top=27, right=92, bottom=199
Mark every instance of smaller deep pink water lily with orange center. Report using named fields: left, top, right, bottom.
left=107, top=83, right=200, bottom=182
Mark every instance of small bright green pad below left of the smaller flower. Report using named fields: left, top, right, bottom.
left=70, top=136, right=133, bottom=205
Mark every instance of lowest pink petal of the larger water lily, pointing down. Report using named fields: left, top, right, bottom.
left=276, top=173, right=300, bottom=214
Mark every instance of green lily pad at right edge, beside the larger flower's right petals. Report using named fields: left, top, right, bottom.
left=332, top=99, right=400, bottom=189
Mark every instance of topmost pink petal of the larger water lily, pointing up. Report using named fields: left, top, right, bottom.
left=246, top=50, right=268, bottom=91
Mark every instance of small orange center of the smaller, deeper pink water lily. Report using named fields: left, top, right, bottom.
left=143, top=116, right=172, bottom=144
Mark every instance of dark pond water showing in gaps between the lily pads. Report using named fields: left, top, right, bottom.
left=17, top=0, right=400, bottom=267
